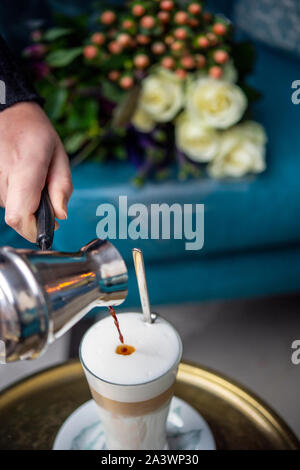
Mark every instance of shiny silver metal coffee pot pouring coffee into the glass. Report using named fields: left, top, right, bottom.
left=0, top=239, right=127, bottom=363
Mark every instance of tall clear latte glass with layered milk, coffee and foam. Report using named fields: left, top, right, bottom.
left=80, top=313, right=182, bottom=450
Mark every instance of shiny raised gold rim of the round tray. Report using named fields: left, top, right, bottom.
left=0, top=359, right=300, bottom=450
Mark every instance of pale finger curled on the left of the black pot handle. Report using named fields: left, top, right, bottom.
left=5, top=158, right=48, bottom=243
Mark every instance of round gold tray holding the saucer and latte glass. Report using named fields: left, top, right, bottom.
left=0, top=361, right=300, bottom=450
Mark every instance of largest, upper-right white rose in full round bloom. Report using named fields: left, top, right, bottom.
left=186, top=78, right=247, bottom=129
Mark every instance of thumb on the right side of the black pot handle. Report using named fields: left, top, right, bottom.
left=47, top=143, right=73, bottom=219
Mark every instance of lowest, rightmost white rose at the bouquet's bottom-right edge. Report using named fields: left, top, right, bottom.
left=208, top=121, right=267, bottom=178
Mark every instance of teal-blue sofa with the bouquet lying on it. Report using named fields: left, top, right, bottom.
left=0, top=0, right=300, bottom=306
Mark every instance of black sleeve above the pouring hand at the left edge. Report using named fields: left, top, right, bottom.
left=0, top=36, right=44, bottom=111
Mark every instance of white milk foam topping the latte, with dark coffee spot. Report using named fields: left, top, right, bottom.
left=81, top=313, right=181, bottom=385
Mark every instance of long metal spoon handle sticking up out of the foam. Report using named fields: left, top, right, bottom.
left=132, top=248, right=156, bottom=323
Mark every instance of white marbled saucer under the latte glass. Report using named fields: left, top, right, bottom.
left=53, top=397, right=216, bottom=450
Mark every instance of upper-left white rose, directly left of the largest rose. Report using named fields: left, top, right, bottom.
left=138, top=69, right=183, bottom=122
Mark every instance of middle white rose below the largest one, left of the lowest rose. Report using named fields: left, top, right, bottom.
left=175, top=112, right=219, bottom=162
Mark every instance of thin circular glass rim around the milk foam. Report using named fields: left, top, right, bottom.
left=79, top=312, right=183, bottom=387
